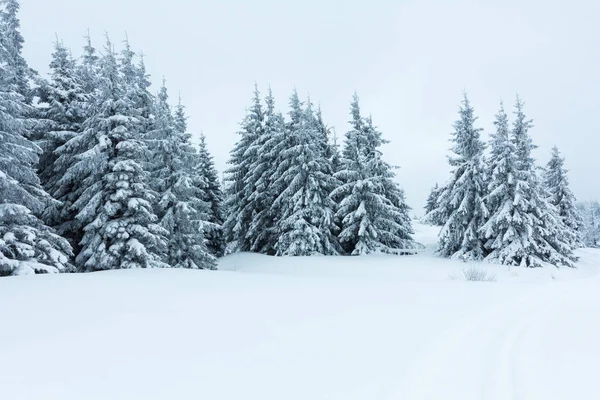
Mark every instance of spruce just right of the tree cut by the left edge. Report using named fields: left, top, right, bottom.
left=37, top=41, right=87, bottom=230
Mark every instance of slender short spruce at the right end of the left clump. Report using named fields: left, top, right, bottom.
left=194, top=133, right=226, bottom=257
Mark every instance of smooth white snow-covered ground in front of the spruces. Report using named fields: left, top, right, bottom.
left=0, top=225, right=600, bottom=400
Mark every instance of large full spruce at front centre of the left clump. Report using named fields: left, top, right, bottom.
left=66, top=36, right=168, bottom=271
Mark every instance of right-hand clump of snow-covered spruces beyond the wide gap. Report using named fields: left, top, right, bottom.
left=425, top=95, right=583, bottom=267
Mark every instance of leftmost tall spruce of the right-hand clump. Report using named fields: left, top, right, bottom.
left=430, top=93, right=488, bottom=260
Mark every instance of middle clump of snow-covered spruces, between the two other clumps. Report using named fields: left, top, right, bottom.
left=224, top=89, right=420, bottom=256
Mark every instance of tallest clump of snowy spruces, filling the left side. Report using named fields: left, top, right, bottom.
left=0, top=0, right=224, bottom=276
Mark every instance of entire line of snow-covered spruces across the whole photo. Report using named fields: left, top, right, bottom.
left=0, top=0, right=600, bottom=276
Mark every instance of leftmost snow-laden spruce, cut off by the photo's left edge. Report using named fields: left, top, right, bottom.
left=0, top=21, right=72, bottom=276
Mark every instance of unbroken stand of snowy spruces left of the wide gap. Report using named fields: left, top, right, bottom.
left=0, top=0, right=420, bottom=275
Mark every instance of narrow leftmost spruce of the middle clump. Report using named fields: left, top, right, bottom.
left=223, top=86, right=264, bottom=252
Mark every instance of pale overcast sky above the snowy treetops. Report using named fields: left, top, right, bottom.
left=20, top=0, right=600, bottom=214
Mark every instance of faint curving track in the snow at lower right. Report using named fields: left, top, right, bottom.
left=387, top=284, right=565, bottom=400
